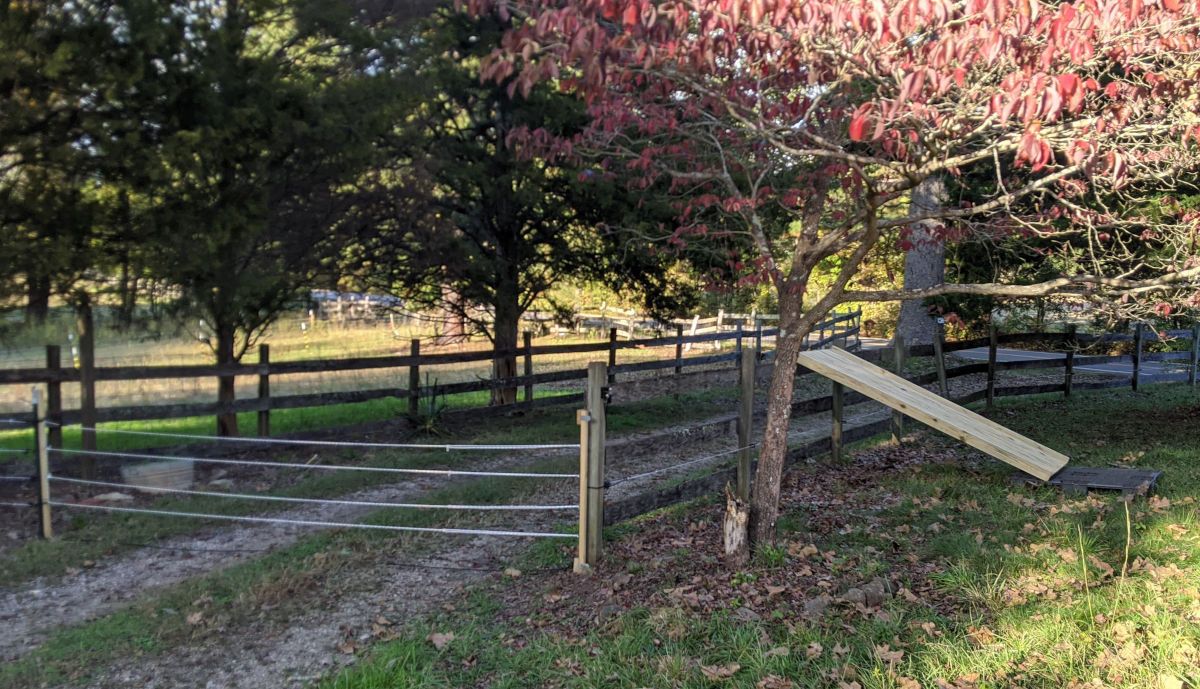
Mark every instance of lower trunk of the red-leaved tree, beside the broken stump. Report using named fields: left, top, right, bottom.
left=750, top=290, right=808, bottom=547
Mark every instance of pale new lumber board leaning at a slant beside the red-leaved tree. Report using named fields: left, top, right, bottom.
left=797, top=349, right=1068, bottom=480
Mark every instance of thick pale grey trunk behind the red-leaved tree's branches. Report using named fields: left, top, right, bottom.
left=896, top=176, right=946, bottom=345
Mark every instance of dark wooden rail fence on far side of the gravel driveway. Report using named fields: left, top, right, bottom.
left=0, top=312, right=862, bottom=436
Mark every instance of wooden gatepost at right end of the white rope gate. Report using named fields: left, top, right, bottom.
left=575, top=361, right=608, bottom=571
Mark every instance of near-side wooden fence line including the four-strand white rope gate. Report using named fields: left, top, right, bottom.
left=0, top=326, right=1200, bottom=571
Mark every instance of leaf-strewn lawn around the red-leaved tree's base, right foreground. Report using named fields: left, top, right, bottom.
left=324, top=385, right=1200, bottom=689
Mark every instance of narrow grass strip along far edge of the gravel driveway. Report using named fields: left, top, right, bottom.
left=0, top=389, right=730, bottom=587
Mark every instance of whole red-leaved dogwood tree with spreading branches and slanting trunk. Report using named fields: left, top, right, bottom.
left=469, top=0, right=1200, bottom=552
